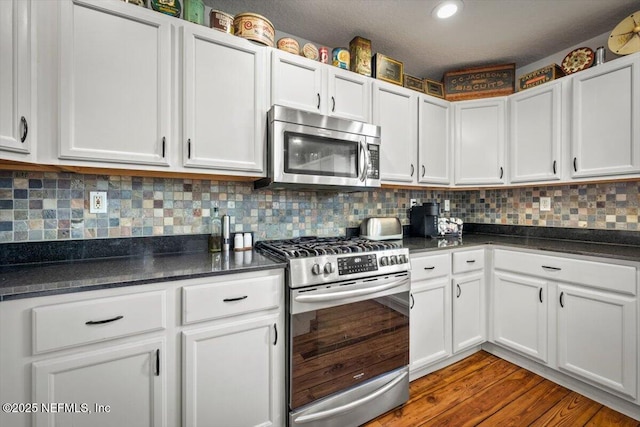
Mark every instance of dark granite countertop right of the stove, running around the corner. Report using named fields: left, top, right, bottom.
left=402, top=234, right=640, bottom=262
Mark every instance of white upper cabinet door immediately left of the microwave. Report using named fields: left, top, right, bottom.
left=182, top=25, right=267, bottom=173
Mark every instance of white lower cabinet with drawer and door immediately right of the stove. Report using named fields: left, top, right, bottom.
left=409, top=253, right=451, bottom=377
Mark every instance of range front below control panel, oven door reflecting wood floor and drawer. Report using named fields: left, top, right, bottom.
left=289, top=272, right=410, bottom=425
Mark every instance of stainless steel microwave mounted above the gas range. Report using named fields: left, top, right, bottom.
left=255, top=105, right=380, bottom=191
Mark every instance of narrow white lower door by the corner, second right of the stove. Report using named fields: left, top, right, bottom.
left=453, top=272, right=486, bottom=353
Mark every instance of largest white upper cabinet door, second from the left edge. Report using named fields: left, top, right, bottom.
left=58, top=0, right=171, bottom=166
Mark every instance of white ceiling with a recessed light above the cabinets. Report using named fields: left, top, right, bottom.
left=205, top=0, right=640, bottom=80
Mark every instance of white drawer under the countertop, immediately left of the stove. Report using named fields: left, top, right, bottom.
left=182, top=274, right=284, bottom=324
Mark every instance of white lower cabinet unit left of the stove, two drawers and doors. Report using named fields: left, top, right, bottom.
left=0, top=269, right=285, bottom=427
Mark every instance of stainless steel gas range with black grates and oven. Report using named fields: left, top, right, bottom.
left=256, top=237, right=410, bottom=427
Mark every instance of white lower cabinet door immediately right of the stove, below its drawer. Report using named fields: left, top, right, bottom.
left=409, top=276, right=451, bottom=371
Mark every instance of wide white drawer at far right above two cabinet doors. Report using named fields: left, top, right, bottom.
left=494, top=249, right=636, bottom=295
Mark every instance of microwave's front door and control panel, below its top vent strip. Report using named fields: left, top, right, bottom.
left=269, top=121, right=380, bottom=188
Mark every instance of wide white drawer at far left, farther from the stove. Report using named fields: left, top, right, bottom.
left=32, top=291, right=166, bottom=354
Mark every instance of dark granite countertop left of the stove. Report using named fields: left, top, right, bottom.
left=0, top=246, right=286, bottom=301
